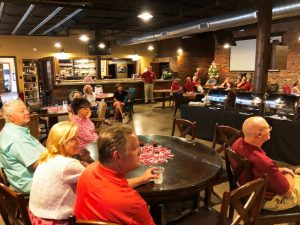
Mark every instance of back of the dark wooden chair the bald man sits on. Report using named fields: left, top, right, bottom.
left=225, top=146, right=253, bottom=190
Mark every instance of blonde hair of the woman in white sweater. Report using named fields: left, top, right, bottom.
left=39, top=121, right=78, bottom=163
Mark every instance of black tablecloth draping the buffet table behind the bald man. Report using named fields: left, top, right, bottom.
left=180, top=105, right=300, bottom=165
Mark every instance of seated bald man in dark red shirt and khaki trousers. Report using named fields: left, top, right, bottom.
left=232, top=116, right=300, bottom=211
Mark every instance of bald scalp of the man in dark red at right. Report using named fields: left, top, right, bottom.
left=243, top=116, right=269, bottom=137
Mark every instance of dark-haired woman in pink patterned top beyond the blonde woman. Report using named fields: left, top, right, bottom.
left=72, top=98, right=98, bottom=162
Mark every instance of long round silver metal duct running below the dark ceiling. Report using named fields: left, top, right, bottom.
left=116, top=0, right=300, bottom=46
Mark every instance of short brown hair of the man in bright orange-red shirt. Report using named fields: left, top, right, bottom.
left=97, top=125, right=134, bottom=164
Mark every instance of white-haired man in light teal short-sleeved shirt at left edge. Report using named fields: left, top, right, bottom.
left=0, top=100, right=45, bottom=194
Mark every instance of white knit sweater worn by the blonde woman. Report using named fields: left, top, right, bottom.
left=29, top=155, right=84, bottom=220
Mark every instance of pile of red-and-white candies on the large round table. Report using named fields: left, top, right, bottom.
left=140, top=144, right=174, bottom=166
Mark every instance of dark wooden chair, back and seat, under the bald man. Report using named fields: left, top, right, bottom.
left=225, top=147, right=300, bottom=225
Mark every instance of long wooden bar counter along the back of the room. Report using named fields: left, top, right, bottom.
left=52, top=78, right=172, bottom=104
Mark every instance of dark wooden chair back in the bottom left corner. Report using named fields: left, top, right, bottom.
left=0, top=183, right=31, bottom=225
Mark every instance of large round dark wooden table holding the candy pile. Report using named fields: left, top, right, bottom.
left=128, top=135, right=222, bottom=225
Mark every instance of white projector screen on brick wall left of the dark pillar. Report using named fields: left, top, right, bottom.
left=229, top=39, right=256, bottom=71
